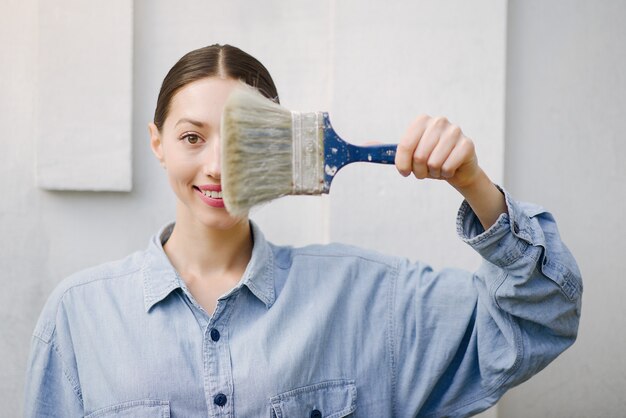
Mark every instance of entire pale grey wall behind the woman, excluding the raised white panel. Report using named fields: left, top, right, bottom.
left=0, top=0, right=626, bottom=417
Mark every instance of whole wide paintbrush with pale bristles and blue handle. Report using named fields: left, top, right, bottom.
left=221, top=84, right=397, bottom=216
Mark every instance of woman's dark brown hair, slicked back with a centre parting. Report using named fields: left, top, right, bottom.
left=154, top=44, right=279, bottom=131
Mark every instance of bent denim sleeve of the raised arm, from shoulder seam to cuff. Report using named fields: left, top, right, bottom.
left=392, top=191, right=582, bottom=417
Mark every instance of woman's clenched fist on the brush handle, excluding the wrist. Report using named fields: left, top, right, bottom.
left=396, top=115, right=481, bottom=188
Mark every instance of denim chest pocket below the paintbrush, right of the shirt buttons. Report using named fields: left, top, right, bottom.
left=270, top=380, right=356, bottom=418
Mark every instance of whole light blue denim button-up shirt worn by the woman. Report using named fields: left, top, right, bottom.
left=25, top=190, right=582, bottom=418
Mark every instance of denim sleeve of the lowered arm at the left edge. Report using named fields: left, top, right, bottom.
left=24, top=294, right=84, bottom=418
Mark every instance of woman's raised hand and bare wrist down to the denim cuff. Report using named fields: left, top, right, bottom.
left=396, top=115, right=507, bottom=229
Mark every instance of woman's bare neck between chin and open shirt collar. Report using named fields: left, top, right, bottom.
left=164, top=211, right=252, bottom=277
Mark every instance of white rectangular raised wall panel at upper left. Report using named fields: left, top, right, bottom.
left=36, top=0, right=132, bottom=191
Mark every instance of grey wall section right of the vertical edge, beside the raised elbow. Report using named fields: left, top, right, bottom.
left=499, top=0, right=626, bottom=418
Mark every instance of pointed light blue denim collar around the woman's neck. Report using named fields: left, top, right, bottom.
left=141, top=221, right=276, bottom=312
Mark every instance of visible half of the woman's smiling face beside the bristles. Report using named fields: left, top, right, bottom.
left=149, top=77, right=247, bottom=229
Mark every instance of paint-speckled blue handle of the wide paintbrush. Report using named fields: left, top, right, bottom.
left=323, top=113, right=397, bottom=193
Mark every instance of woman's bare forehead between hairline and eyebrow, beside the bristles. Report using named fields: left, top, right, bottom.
left=168, top=77, right=241, bottom=118
